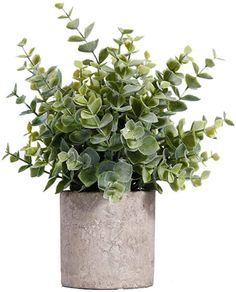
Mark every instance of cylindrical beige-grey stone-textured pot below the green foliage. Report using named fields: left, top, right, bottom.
left=60, top=191, right=155, bottom=289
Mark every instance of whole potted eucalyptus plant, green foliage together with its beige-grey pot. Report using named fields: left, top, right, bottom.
left=4, top=3, right=233, bottom=289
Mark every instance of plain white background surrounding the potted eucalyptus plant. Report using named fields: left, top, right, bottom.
left=0, top=0, right=236, bottom=292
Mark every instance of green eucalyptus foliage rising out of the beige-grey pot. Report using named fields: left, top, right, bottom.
left=2, top=3, right=233, bottom=202
